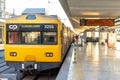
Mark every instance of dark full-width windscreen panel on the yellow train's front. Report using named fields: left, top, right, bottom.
left=6, top=25, right=57, bottom=45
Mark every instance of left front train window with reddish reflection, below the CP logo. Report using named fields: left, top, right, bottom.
left=7, top=32, right=20, bottom=44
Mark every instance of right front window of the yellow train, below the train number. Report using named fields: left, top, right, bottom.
left=43, top=32, right=57, bottom=44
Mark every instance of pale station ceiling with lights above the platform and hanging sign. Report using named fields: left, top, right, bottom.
left=59, top=0, right=120, bottom=32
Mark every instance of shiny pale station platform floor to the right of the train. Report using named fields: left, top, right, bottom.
left=56, top=42, right=120, bottom=80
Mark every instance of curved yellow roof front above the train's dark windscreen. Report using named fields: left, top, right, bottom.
left=6, top=14, right=60, bottom=24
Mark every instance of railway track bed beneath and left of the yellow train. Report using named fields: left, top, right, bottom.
left=0, top=50, right=59, bottom=80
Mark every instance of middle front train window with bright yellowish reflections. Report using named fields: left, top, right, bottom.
left=22, top=32, right=40, bottom=44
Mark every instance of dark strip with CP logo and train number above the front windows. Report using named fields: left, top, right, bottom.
left=6, top=24, right=57, bottom=31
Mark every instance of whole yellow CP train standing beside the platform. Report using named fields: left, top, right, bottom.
left=4, top=14, right=74, bottom=71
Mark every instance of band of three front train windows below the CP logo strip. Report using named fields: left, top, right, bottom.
left=7, top=31, right=57, bottom=44
